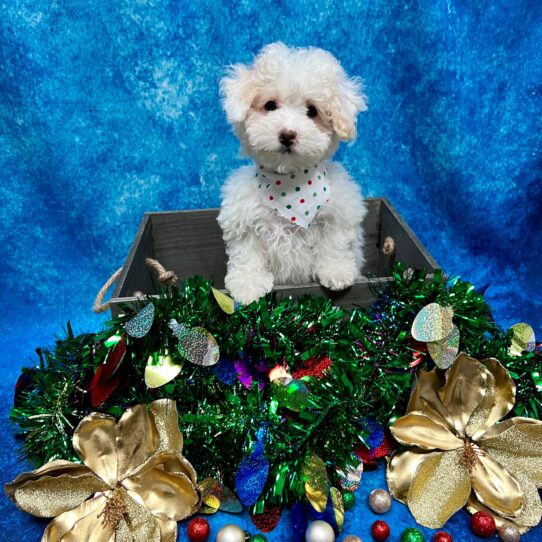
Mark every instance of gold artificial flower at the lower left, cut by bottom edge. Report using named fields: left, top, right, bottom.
left=6, top=399, right=199, bottom=542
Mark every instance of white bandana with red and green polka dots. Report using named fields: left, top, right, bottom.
left=255, top=164, right=330, bottom=228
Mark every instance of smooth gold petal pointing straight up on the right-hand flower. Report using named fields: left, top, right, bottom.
left=439, top=353, right=491, bottom=437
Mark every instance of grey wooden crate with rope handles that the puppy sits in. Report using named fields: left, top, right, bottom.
left=111, top=198, right=438, bottom=316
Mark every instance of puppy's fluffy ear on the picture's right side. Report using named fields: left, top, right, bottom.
left=331, top=74, right=367, bottom=141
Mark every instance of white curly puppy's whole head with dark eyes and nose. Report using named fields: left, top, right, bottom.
left=221, top=43, right=366, bottom=172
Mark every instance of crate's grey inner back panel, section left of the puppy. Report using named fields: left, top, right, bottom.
left=152, top=209, right=226, bottom=288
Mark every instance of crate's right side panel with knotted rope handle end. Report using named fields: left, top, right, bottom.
left=378, top=199, right=438, bottom=275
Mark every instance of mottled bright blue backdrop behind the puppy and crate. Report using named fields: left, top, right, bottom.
left=0, top=0, right=542, bottom=541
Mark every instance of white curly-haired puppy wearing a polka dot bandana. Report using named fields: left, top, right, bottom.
left=218, top=43, right=367, bottom=304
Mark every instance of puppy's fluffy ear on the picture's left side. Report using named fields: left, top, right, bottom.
left=220, top=64, right=256, bottom=124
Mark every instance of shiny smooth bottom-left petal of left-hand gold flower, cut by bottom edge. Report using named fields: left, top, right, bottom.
left=41, top=495, right=115, bottom=542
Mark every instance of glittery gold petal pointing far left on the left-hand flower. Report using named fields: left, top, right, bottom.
left=6, top=472, right=108, bottom=518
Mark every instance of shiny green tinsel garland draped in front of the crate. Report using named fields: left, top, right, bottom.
left=11, top=265, right=542, bottom=510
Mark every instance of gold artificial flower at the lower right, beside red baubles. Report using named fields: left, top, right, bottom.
left=387, top=354, right=542, bottom=532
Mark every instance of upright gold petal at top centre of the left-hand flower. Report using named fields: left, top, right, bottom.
left=117, top=405, right=158, bottom=480
